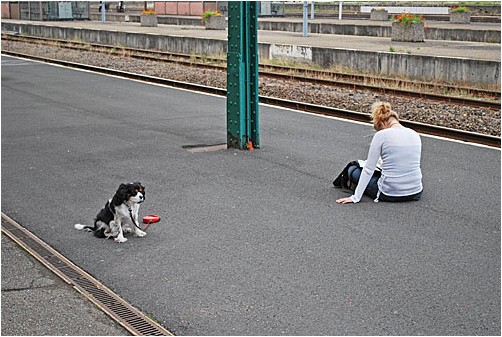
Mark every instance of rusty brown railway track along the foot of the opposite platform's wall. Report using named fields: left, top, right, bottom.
left=2, top=34, right=501, bottom=110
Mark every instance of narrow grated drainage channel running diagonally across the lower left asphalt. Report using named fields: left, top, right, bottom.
left=2, top=212, right=174, bottom=336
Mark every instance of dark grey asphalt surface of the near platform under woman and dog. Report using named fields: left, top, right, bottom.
left=1, top=17, right=501, bottom=335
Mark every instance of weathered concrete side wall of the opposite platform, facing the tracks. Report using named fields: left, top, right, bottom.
left=2, top=22, right=501, bottom=85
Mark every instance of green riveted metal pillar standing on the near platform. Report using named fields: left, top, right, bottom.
left=227, top=1, right=260, bottom=150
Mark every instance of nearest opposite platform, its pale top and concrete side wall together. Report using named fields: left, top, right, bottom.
left=2, top=20, right=500, bottom=86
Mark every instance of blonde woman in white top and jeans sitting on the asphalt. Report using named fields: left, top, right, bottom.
left=336, top=102, right=423, bottom=204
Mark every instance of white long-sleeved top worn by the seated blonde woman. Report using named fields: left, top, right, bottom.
left=350, top=127, right=423, bottom=203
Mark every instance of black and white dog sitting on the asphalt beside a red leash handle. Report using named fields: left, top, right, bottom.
left=75, top=182, right=146, bottom=242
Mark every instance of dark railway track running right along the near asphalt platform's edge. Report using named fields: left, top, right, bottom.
left=2, top=50, right=500, bottom=148
